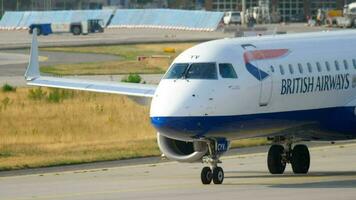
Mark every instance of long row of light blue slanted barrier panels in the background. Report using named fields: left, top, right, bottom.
left=0, top=9, right=223, bottom=31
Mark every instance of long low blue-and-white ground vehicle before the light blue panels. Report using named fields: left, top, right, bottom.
left=29, top=19, right=104, bottom=35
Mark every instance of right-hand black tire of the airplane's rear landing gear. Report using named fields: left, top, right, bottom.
left=291, top=144, right=310, bottom=174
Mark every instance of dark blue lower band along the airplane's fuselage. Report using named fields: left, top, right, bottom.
left=151, top=107, right=356, bottom=138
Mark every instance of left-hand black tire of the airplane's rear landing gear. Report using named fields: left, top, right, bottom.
left=267, top=145, right=286, bottom=174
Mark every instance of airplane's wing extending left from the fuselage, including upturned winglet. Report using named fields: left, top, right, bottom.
left=25, top=32, right=157, bottom=97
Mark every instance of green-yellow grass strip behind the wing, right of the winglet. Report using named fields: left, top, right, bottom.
left=41, top=43, right=195, bottom=75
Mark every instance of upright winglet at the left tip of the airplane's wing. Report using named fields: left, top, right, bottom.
left=25, top=29, right=40, bottom=81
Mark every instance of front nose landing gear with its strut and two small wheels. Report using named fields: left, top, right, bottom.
left=200, top=139, right=224, bottom=185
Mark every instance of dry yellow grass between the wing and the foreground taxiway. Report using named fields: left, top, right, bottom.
left=0, top=88, right=266, bottom=170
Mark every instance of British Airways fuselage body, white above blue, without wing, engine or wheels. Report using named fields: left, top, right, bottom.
left=150, top=31, right=356, bottom=139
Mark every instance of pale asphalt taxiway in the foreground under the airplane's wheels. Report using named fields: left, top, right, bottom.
left=0, top=143, right=356, bottom=200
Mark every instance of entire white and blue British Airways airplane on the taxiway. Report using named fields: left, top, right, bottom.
left=25, top=31, right=356, bottom=184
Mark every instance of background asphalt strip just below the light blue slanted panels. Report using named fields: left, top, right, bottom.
left=0, top=28, right=233, bottom=49
